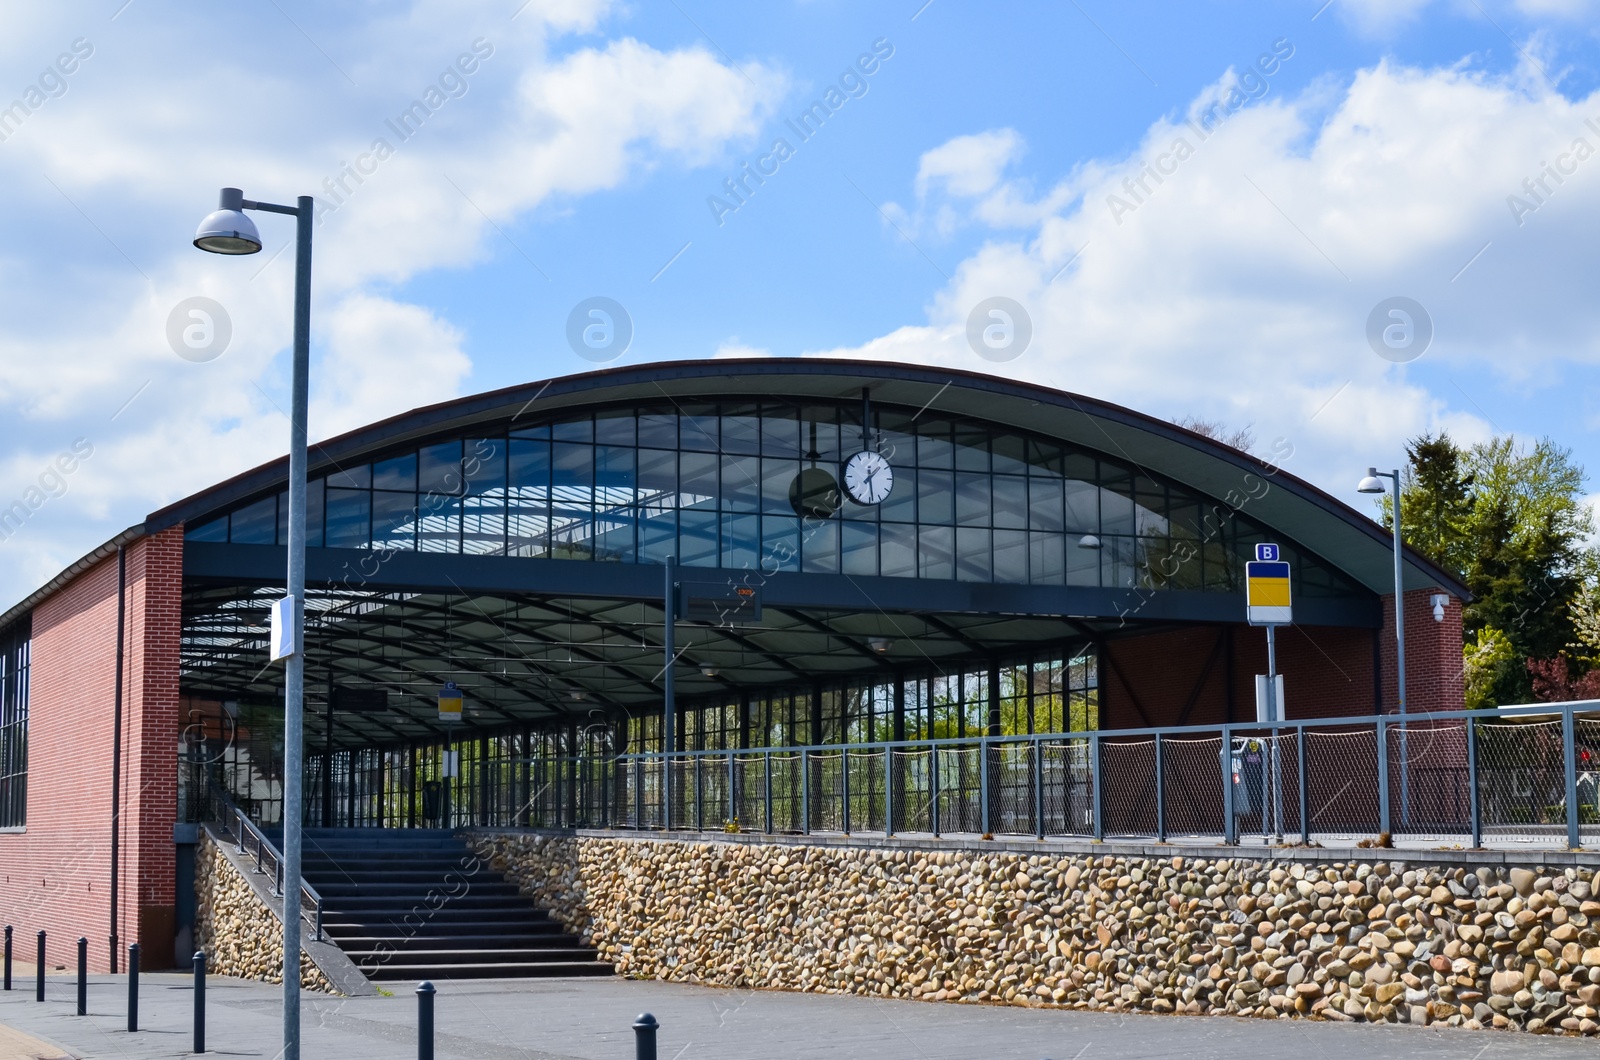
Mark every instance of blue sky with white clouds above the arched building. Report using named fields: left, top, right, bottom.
left=0, top=0, right=1600, bottom=607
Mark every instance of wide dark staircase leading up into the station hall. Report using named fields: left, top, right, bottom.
left=291, top=828, right=611, bottom=980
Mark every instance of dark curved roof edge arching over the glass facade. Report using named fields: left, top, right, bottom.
left=144, top=357, right=1469, bottom=597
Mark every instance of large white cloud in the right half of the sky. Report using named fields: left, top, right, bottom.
left=827, top=52, right=1600, bottom=492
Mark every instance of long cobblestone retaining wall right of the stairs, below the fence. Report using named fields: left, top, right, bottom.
left=472, top=833, right=1600, bottom=1034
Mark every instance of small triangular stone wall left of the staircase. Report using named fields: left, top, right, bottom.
left=195, top=829, right=336, bottom=994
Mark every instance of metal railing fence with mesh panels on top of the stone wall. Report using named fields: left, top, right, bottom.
left=512, top=701, right=1600, bottom=849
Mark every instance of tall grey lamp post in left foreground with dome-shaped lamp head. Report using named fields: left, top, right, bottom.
left=195, top=187, right=312, bottom=1060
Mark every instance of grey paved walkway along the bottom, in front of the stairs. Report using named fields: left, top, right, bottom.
left=0, top=975, right=1595, bottom=1060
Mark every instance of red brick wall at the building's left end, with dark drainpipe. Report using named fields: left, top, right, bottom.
left=0, top=527, right=182, bottom=970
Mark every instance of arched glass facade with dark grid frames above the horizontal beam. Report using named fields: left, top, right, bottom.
left=187, top=402, right=1355, bottom=596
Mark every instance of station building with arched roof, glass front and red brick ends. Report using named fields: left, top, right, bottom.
left=0, top=359, right=1466, bottom=967
